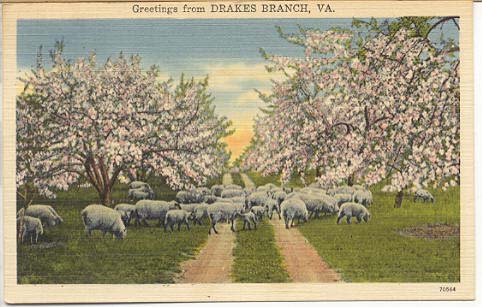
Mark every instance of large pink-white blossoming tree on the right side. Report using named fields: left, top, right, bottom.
left=245, top=18, right=460, bottom=207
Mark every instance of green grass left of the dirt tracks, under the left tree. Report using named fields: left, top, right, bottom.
left=17, top=177, right=220, bottom=284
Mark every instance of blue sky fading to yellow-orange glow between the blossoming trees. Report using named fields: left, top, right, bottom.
left=17, top=18, right=455, bottom=159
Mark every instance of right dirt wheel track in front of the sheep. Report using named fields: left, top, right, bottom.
left=271, top=217, right=341, bottom=282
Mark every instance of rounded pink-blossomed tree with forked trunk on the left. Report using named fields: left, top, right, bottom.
left=17, top=44, right=232, bottom=205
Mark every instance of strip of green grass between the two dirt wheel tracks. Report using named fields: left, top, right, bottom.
left=233, top=220, right=289, bottom=283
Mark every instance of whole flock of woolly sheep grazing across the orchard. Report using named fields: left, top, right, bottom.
left=17, top=181, right=434, bottom=243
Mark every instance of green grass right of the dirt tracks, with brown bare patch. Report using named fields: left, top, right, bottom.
left=249, top=173, right=460, bottom=282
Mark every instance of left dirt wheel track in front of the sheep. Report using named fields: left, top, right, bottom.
left=176, top=224, right=236, bottom=283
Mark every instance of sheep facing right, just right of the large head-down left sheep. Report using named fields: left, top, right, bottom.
left=136, top=200, right=181, bottom=226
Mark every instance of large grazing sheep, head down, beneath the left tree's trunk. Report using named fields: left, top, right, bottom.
left=81, top=204, right=127, bottom=239
